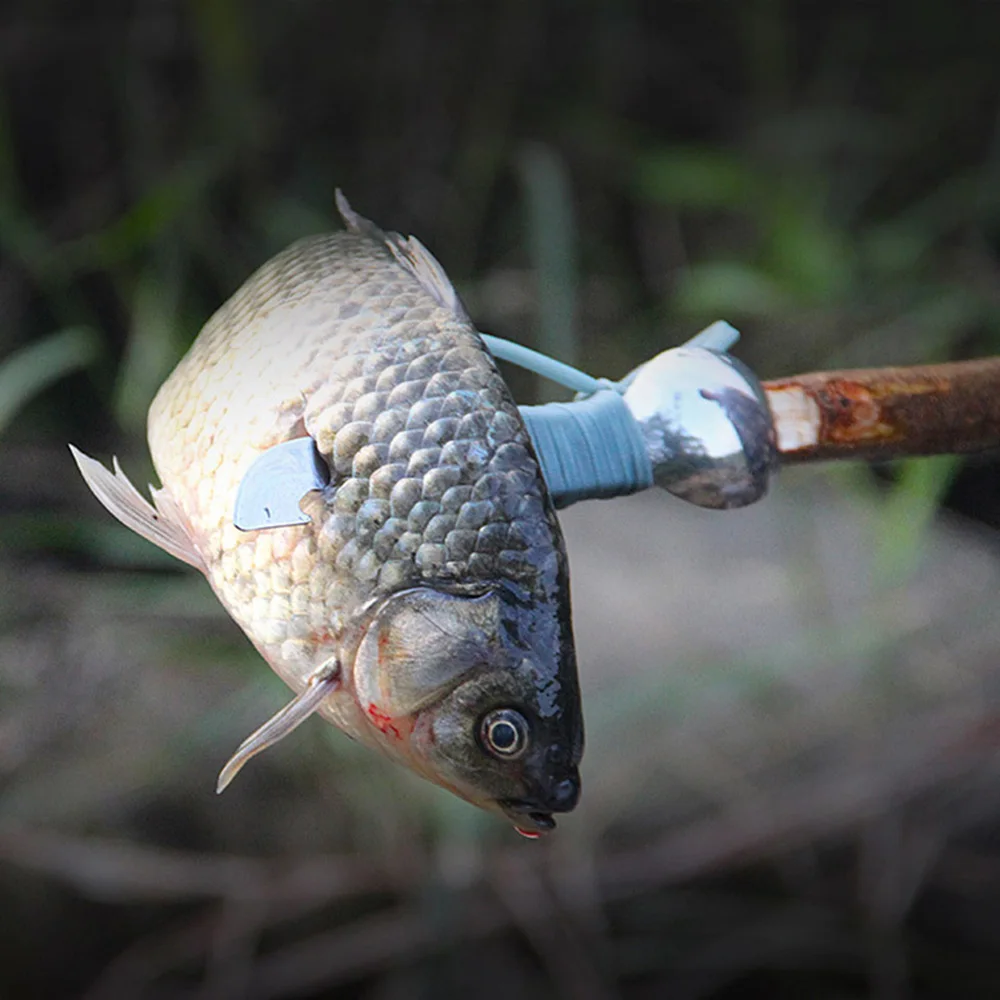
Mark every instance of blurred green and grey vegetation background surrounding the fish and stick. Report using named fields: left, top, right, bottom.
left=0, top=0, right=1000, bottom=1000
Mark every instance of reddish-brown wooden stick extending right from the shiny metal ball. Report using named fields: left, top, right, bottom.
left=763, top=358, right=1000, bottom=463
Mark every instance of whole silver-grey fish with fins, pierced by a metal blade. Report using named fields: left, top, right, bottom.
left=70, top=190, right=584, bottom=837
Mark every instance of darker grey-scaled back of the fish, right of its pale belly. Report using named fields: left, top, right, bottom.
left=290, top=233, right=565, bottom=596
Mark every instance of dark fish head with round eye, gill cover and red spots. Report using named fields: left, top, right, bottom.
left=353, top=584, right=583, bottom=836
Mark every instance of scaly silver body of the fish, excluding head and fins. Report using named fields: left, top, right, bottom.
left=149, top=233, right=562, bottom=735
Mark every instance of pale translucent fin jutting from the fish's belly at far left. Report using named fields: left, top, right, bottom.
left=69, top=445, right=205, bottom=573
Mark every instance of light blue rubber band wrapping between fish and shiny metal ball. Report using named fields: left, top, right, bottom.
left=521, top=389, right=653, bottom=508
